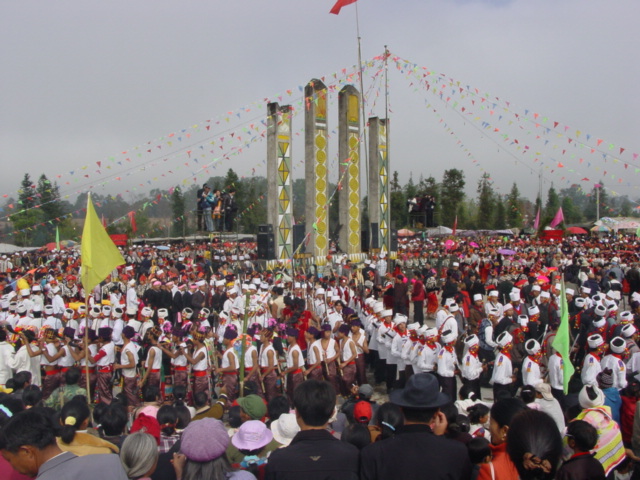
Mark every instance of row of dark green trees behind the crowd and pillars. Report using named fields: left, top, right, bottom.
left=0, top=168, right=636, bottom=246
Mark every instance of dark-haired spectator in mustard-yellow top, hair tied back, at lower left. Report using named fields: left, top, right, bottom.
left=58, top=397, right=119, bottom=456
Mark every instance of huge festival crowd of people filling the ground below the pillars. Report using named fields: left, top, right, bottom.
left=0, top=231, right=640, bottom=479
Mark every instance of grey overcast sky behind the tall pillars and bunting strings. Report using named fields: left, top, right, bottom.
left=0, top=0, right=640, bottom=210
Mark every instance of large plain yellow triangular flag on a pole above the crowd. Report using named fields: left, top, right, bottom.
left=80, top=194, right=125, bottom=295
